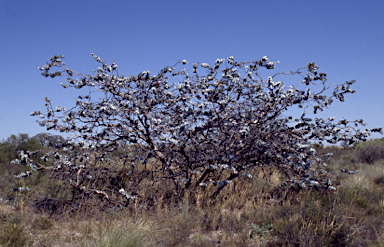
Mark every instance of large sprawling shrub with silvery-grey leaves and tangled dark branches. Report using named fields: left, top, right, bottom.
left=14, top=54, right=382, bottom=206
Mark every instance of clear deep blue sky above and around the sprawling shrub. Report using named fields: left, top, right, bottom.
left=0, top=0, right=384, bottom=141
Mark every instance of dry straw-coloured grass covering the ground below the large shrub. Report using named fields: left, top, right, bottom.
left=0, top=143, right=384, bottom=246
